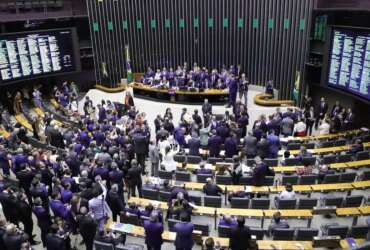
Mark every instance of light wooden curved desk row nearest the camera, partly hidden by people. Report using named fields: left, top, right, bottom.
left=106, top=222, right=364, bottom=250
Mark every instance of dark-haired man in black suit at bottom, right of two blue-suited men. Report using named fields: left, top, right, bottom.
left=229, top=217, right=251, bottom=250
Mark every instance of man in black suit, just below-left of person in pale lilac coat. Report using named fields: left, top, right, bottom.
left=77, top=207, right=98, bottom=250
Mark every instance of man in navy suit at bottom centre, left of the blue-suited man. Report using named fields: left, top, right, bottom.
left=144, top=213, right=164, bottom=250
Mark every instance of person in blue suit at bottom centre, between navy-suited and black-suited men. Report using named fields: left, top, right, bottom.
left=173, top=214, right=194, bottom=250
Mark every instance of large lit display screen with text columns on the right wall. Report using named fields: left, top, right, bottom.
left=328, top=28, right=370, bottom=100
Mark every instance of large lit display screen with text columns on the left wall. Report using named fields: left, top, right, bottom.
left=0, top=29, right=80, bottom=83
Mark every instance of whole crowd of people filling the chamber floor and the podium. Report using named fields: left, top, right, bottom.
left=0, top=76, right=361, bottom=250
